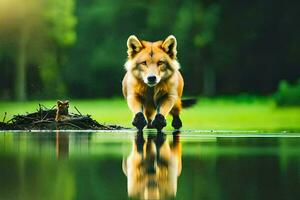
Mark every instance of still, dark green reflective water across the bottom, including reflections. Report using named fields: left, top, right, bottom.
left=0, top=132, right=300, bottom=200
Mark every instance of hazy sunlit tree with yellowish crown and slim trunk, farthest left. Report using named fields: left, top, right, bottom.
left=0, top=0, right=39, bottom=100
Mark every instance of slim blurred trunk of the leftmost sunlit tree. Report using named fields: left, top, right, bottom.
left=15, top=24, right=29, bottom=101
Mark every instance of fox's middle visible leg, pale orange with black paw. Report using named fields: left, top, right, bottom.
left=152, top=95, right=177, bottom=131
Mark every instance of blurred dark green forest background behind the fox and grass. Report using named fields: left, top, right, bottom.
left=0, top=0, right=300, bottom=104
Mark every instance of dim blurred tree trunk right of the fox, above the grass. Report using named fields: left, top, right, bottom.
left=203, top=65, right=216, bottom=96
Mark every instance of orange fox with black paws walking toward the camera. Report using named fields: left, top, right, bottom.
left=122, top=35, right=196, bottom=131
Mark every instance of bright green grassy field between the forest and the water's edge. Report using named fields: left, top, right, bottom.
left=0, top=98, right=300, bottom=131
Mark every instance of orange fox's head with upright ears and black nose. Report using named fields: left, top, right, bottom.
left=125, top=35, right=180, bottom=87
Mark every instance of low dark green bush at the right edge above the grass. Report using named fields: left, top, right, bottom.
left=274, top=79, right=300, bottom=106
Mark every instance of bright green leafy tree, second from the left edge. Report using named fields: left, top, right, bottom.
left=37, top=0, right=77, bottom=98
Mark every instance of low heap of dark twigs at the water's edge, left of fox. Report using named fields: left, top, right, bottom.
left=0, top=105, right=124, bottom=130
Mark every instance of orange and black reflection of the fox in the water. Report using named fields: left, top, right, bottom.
left=122, top=132, right=182, bottom=199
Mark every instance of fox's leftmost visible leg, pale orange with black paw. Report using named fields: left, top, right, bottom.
left=127, top=95, right=147, bottom=131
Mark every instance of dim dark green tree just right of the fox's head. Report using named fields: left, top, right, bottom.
left=174, top=1, right=220, bottom=96
